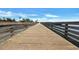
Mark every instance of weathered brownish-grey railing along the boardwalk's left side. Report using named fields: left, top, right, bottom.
left=0, top=23, right=36, bottom=43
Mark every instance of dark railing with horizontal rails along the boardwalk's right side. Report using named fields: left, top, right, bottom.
left=42, top=22, right=79, bottom=47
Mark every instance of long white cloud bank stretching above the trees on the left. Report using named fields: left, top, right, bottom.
left=0, top=10, right=38, bottom=18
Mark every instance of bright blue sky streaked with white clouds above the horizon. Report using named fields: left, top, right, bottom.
left=0, top=8, right=79, bottom=22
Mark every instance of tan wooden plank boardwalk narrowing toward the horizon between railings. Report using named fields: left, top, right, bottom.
left=0, top=24, right=78, bottom=50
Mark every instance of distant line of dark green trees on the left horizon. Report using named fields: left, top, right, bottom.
left=0, top=17, right=37, bottom=22
